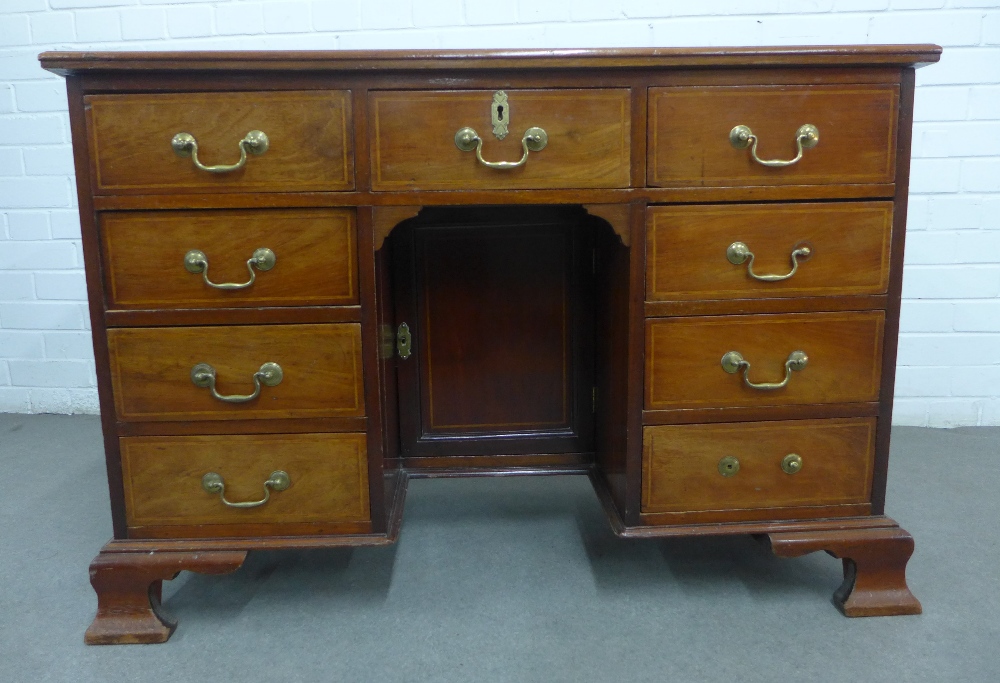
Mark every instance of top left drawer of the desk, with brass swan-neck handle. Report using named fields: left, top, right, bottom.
left=84, top=90, right=354, bottom=194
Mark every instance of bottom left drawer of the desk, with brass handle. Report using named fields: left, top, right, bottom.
left=121, top=434, right=370, bottom=527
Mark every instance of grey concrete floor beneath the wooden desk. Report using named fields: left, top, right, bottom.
left=0, top=415, right=1000, bottom=683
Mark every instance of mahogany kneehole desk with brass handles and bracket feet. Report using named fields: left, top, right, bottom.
left=41, top=45, right=940, bottom=643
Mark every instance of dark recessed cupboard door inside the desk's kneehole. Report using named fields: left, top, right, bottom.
left=393, top=207, right=597, bottom=458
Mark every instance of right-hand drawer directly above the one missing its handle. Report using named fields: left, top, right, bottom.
left=646, top=311, right=884, bottom=410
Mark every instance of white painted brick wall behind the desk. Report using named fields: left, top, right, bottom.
left=0, top=0, right=1000, bottom=426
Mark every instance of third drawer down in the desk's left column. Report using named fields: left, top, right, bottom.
left=108, top=323, right=364, bottom=421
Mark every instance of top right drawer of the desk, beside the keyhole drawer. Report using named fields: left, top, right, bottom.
left=648, top=85, right=899, bottom=187
